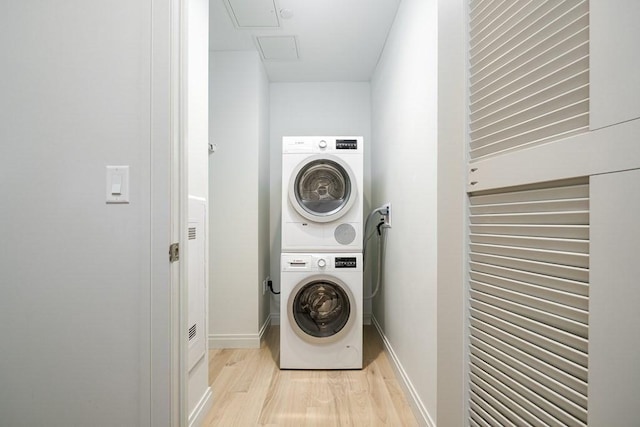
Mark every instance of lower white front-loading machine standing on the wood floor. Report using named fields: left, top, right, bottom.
left=280, top=253, right=363, bottom=369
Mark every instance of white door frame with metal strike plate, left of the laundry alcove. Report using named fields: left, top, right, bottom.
left=149, top=0, right=188, bottom=427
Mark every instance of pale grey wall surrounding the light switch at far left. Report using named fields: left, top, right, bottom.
left=0, top=0, right=171, bottom=426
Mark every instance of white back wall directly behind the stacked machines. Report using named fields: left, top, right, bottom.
left=270, top=82, right=371, bottom=319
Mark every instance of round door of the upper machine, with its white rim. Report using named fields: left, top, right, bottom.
left=289, top=155, right=357, bottom=222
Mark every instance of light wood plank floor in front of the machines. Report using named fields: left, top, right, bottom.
left=203, top=326, right=418, bottom=427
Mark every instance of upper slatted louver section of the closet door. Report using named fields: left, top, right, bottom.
left=469, top=0, right=589, bottom=159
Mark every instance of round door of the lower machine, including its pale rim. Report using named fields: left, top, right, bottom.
left=287, top=276, right=356, bottom=343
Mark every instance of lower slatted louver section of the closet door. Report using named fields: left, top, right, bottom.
left=469, top=181, right=589, bottom=427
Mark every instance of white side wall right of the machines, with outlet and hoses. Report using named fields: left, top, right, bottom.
left=371, top=0, right=438, bottom=423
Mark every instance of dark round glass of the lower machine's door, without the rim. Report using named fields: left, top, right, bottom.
left=289, top=280, right=351, bottom=338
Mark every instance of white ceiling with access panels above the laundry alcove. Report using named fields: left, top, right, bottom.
left=209, top=0, right=401, bottom=82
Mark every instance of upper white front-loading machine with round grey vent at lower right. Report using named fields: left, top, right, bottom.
left=282, top=136, right=364, bottom=252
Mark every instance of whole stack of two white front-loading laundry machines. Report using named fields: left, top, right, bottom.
left=280, top=136, right=364, bottom=369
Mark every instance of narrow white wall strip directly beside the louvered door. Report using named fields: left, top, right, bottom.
left=436, top=0, right=467, bottom=427
